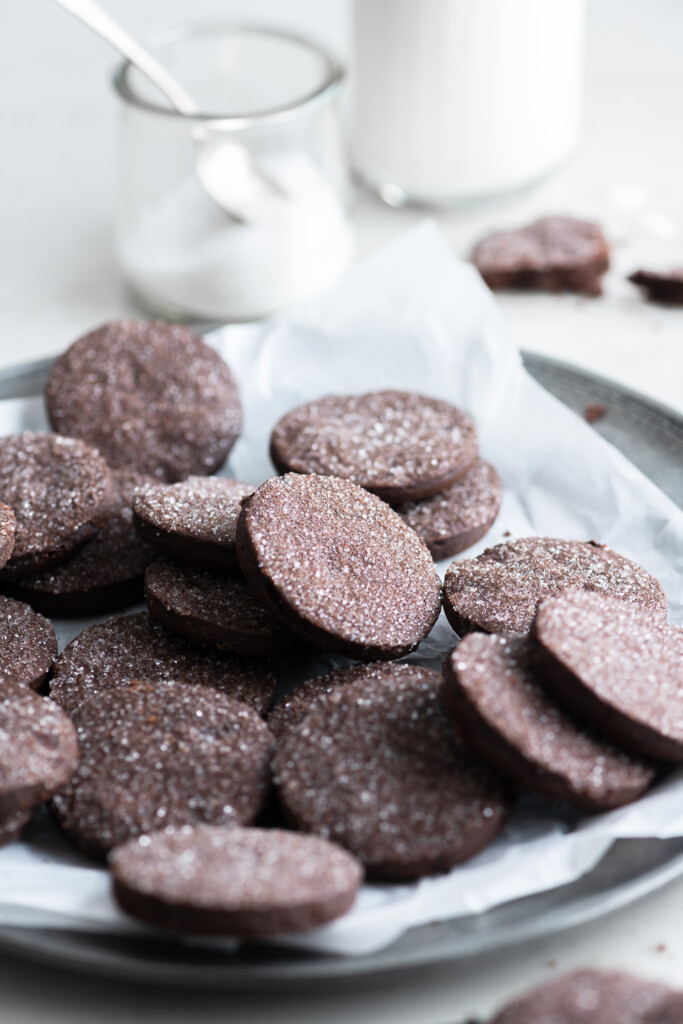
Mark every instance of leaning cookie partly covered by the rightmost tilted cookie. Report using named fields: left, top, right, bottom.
left=441, top=633, right=654, bottom=811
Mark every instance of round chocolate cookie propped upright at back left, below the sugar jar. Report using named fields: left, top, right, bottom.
left=45, top=319, right=242, bottom=481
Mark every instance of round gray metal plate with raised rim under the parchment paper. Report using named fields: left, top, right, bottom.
left=0, top=355, right=683, bottom=991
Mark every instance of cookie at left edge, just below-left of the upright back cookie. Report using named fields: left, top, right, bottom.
left=0, top=431, right=111, bottom=580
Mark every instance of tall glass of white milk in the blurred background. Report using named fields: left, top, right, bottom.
left=352, top=0, right=585, bottom=205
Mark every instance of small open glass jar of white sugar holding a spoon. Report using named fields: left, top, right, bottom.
left=115, top=22, right=353, bottom=322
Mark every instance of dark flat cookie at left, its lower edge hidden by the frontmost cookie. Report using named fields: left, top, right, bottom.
left=52, top=681, right=273, bottom=857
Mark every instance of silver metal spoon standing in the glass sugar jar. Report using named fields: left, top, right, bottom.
left=54, top=0, right=282, bottom=224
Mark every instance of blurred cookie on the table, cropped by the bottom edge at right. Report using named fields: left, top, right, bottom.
left=492, top=971, right=683, bottom=1024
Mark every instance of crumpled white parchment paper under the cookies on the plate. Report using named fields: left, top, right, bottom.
left=0, top=223, right=683, bottom=954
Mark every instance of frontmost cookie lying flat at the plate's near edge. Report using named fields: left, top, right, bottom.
left=110, top=825, right=362, bottom=939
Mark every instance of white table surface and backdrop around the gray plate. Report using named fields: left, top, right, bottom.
left=0, top=0, right=683, bottom=1024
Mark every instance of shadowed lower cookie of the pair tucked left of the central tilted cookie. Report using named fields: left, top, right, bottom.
left=144, top=558, right=292, bottom=657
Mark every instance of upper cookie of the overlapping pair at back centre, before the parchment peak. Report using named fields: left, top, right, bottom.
left=270, top=391, right=478, bottom=504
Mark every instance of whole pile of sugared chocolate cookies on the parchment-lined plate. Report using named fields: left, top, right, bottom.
left=0, top=321, right=683, bottom=938
